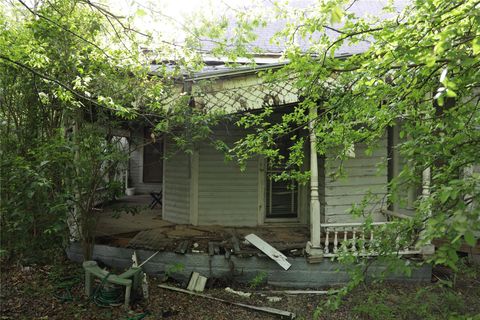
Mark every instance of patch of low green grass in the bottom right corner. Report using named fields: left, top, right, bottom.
left=344, top=264, right=480, bottom=320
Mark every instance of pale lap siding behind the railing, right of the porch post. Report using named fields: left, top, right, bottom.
left=325, top=138, right=388, bottom=223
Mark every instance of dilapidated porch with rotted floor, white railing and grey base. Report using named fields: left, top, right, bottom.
left=76, top=195, right=431, bottom=288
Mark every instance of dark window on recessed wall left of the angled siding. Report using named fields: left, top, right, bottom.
left=143, top=129, right=163, bottom=183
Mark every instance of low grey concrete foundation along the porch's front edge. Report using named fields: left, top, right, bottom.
left=67, top=243, right=432, bottom=289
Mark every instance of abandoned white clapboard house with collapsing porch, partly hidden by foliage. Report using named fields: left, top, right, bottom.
left=69, top=1, right=432, bottom=287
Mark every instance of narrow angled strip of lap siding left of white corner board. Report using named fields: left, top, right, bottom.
left=163, top=141, right=190, bottom=223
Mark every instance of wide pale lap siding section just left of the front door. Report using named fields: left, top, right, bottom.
left=198, top=128, right=258, bottom=226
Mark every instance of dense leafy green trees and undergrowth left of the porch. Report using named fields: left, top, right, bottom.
left=0, top=0, right=172, bottom=259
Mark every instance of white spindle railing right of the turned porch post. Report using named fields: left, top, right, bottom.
left=321, top=221, right=420, bottom=257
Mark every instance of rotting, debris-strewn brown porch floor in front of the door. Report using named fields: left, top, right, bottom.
left=95, top=195, right=309, bottom=256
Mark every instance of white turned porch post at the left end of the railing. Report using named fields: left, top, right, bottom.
left=307, top=106, right=320, bottom=252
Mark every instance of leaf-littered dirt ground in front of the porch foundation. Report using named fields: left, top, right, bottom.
left=0, top=261, right=480, bottom=320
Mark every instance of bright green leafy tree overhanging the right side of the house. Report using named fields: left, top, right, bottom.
left=192, top=0, right=480, bottom=306
